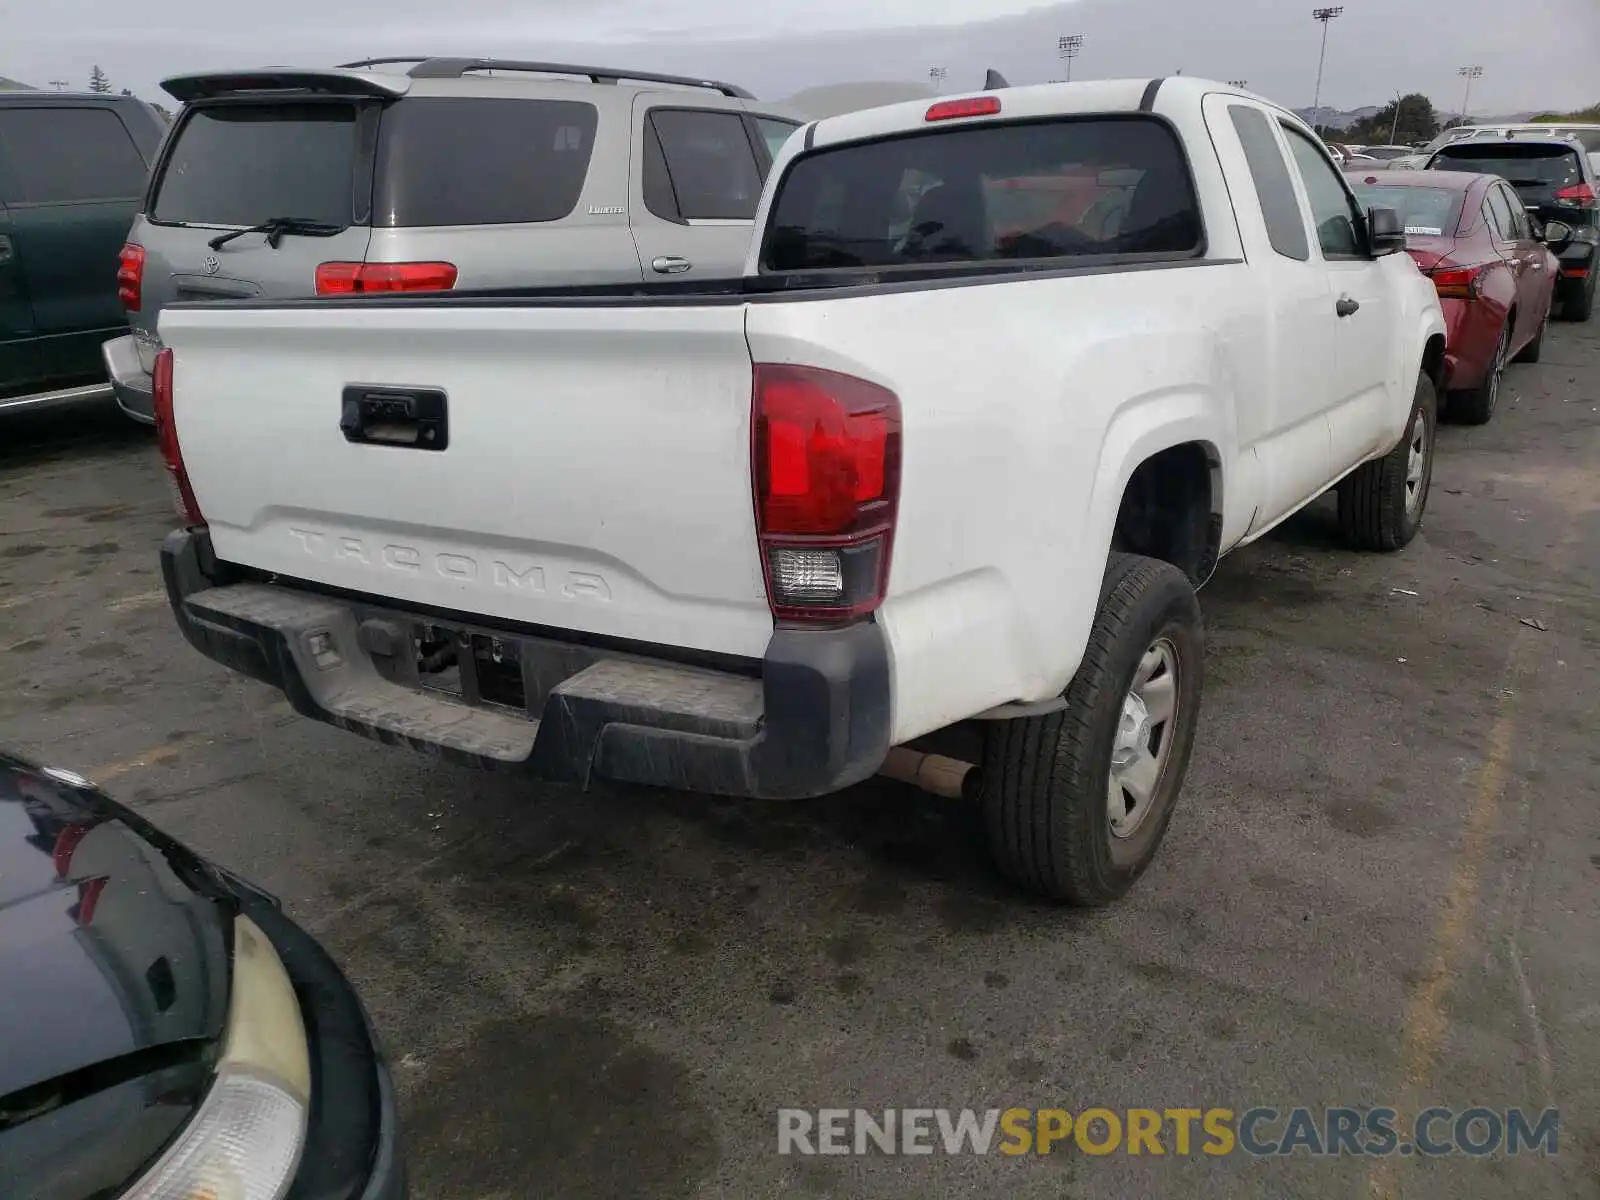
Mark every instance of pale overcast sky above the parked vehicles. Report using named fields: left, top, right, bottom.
left=0, top=0, right=1600, bottom=115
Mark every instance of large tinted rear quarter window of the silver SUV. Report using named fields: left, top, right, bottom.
left=373, top=96, right=600, bottom=227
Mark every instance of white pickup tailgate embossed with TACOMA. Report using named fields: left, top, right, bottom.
left=160, top=302, right=773, bottom=658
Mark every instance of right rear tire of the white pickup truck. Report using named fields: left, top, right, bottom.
left=982, top=554, right=1205, bottom=907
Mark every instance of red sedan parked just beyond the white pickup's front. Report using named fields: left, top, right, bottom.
left=1346, top=171, right=1571, bottom=426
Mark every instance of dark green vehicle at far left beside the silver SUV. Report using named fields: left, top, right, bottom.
left=0, top=91, right=166, bottom=413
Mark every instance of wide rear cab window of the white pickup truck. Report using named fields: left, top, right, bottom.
left=762, top=117, right=1202, bottom=272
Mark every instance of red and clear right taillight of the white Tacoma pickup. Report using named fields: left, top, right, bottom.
left=750, top=363, right=901, bottom=626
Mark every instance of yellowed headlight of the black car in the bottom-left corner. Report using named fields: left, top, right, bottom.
left=123, top=917, right=310, bottom=1200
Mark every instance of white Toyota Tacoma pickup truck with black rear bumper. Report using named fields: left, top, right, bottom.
left=155, top=77, right=1445, bottom=904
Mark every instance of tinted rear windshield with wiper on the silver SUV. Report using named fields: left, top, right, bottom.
left=150, top=104, right=357, bottom=226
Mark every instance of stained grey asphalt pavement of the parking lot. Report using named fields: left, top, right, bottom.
left=0, top=322, right=1600, bottom=1200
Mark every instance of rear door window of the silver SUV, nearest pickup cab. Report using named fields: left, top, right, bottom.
left=645, top=109, right=762, bottom=221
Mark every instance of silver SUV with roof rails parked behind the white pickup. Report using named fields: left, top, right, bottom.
left=104, top=58, right=803, bottom=421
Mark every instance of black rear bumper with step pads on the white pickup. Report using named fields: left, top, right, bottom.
left=162, top=531, right=891, bottom=798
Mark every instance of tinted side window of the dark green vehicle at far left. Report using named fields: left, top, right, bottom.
left=0, top=107, right=149, bottom=203
